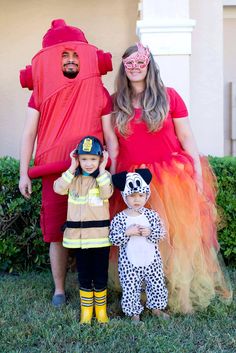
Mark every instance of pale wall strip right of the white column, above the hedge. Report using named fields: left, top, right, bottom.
left=190, top=0, right=224, bottom=156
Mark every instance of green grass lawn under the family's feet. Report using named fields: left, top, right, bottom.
left=0, top=269, right=236, bottom=353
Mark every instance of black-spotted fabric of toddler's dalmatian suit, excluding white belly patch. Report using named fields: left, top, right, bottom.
left=109, top=208, right=168, bottom=316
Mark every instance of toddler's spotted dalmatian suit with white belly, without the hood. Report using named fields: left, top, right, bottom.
left=109, top=207, right=168, bottom=316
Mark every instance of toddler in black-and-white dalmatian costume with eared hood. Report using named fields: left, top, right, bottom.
left=109, top=169, right=168, bottom=321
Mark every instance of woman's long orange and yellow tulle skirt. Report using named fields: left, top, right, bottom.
left=109, top=156, right=232, bottom=313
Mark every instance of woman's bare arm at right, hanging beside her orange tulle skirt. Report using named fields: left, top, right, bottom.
left=173, top=118, right=203, bottom=191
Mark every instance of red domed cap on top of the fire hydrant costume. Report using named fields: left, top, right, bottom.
left=42, top=19, right=88, bottom=48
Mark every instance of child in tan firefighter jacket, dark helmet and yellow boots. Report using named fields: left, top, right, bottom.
left=54, top=136, right=113, bottom=324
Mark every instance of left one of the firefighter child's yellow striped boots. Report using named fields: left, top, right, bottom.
left=79, top=289, right=93, bottom=324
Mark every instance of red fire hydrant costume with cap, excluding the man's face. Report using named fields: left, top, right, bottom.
left=20, top=20, right=112, bottom=178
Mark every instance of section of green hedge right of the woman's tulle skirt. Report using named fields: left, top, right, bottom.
left=209, top=157, right=236, bottom=265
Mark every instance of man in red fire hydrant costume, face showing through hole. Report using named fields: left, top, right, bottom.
left=19, top=19, right=112, bottom=307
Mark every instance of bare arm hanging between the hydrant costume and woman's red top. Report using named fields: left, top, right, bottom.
left=102, top=114, right=119, bottom=174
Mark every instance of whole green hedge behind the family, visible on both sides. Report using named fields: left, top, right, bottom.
left=0, top=157, right=236, bottom=272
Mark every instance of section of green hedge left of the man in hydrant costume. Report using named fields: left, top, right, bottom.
left=0, top=157, right=49, bottom=272
